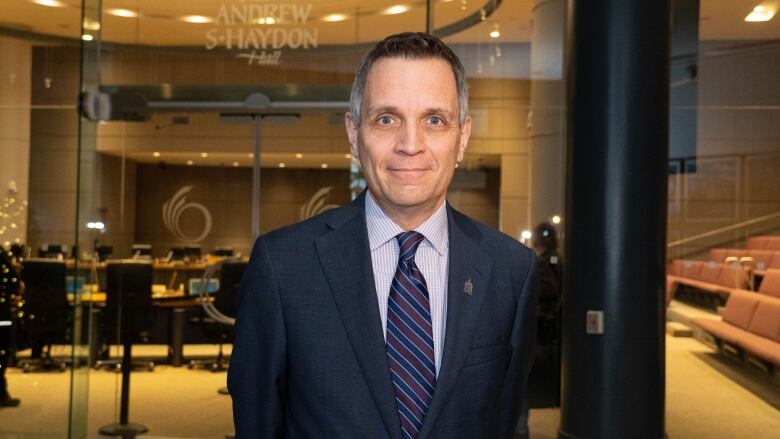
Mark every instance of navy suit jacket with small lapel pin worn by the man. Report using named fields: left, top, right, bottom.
left=228, top=193, right=537, bottom=439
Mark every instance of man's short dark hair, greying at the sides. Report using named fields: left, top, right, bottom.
left=349, top=32, right=469, bottom=125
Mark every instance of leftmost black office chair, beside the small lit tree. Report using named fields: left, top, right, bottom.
left=20, top=259, right=70, bottom=373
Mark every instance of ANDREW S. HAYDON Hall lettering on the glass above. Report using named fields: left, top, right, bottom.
left=206, top=0, right=319, bottom=65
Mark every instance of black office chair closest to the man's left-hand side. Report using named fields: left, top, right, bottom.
left=188, top=259, right=247, bottom=372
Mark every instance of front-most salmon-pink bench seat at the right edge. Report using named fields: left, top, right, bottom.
left=693, top=290, right=780, bottom=373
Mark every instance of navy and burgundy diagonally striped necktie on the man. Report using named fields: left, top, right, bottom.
left=386, top=232, right=436, bottom=439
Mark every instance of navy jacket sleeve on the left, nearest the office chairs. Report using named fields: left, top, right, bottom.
left=228, top=238, right=287, bottom=439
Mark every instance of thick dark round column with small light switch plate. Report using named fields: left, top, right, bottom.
left=559, top=0, right=670, bottom=439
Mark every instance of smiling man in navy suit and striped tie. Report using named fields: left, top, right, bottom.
left=228, top=33, right=537, bottom=439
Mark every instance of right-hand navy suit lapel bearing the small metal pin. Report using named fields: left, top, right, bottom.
left=419, top=206, right=493, bottom=439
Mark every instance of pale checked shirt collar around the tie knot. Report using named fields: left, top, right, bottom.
left=366, top=190, right=449, bottom=255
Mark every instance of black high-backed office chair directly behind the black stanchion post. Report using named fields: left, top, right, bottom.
left=94, top=259, right=154, bottom=373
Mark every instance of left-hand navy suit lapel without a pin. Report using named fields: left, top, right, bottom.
left=316, top=195, right=401, bottom=439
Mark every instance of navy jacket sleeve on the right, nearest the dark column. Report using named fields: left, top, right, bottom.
left=499, top=252, right=539, bottom=438
